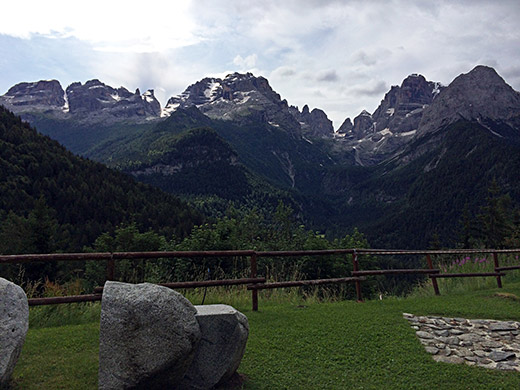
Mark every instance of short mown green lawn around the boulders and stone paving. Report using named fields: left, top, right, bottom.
left=10, top=283, right=520, bottom=390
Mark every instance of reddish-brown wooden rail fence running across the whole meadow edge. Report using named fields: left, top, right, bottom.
left=0, top=249, right=520, bottom=311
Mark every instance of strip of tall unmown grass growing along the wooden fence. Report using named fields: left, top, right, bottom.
left=24, top=254, right=520, bottom=328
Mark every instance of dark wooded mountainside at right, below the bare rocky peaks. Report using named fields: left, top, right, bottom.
left=320, top=121, right=520, bottom=248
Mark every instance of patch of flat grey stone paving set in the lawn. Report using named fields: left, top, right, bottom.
left=403, top=313, right=520, bottom=371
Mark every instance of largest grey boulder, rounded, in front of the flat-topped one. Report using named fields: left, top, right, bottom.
left=99, top=282, right=200, bottom=390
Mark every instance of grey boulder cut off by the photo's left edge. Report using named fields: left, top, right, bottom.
left=0, top=278, right=29, bottom=388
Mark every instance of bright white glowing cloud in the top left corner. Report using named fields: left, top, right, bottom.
left=0, top=0, right=201, bottom=52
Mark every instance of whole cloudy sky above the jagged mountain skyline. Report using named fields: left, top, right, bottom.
left=0, top=0, right=520, bottom=128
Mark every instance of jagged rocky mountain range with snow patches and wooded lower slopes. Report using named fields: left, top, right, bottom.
left=0, top=66, right=520, bottom=247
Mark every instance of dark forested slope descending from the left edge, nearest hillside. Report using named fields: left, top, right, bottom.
left=0, top=107, right=202, bottom=250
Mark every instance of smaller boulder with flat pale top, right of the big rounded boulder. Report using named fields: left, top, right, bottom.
left=179, top=305, right=249, bottom=390
